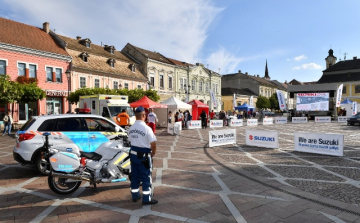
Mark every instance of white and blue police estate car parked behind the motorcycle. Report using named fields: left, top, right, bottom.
left=13, top=114, right=126, bottom=175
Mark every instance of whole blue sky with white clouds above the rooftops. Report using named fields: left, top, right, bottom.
left=0, top=0, right=360, bottom=82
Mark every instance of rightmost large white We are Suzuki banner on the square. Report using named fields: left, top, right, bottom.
left=294, top=132, right=344, bottom=156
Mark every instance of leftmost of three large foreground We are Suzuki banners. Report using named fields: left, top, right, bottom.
left=209, top=129, right=236, bottom=147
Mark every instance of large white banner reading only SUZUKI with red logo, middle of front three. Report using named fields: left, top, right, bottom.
left=245, top=129, right=279, bottom=149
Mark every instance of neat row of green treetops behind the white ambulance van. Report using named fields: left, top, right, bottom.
left=68, top=88, right=160, bottom=104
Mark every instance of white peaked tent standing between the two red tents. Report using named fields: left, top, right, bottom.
left=154, top=96, right=192, bottom=127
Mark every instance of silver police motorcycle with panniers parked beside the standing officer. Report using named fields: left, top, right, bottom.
left=42, top=129, right=130, bottom=195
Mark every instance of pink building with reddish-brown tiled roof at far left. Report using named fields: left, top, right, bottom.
left=0, top=18, right=71, bottom=124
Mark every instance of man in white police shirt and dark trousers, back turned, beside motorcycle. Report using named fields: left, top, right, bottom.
left=128, top=106, right=158, bottom=205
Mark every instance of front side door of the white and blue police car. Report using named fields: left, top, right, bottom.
left=84, top=117, right=115, bottom=152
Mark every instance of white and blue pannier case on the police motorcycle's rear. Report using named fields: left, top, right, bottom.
left=50, top=152, right=80, bottom=173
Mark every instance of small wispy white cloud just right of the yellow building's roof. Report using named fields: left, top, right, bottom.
left=206, top=47, right=247, bottom=74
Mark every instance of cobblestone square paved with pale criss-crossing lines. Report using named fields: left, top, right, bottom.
left=0, top=123, right=360, bottom=223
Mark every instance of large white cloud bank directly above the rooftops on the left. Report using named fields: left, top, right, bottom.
left=2, top=0, right=223, bottom=62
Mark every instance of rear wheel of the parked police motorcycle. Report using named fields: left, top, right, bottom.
left=48, top=173, right=81, bottom=195
